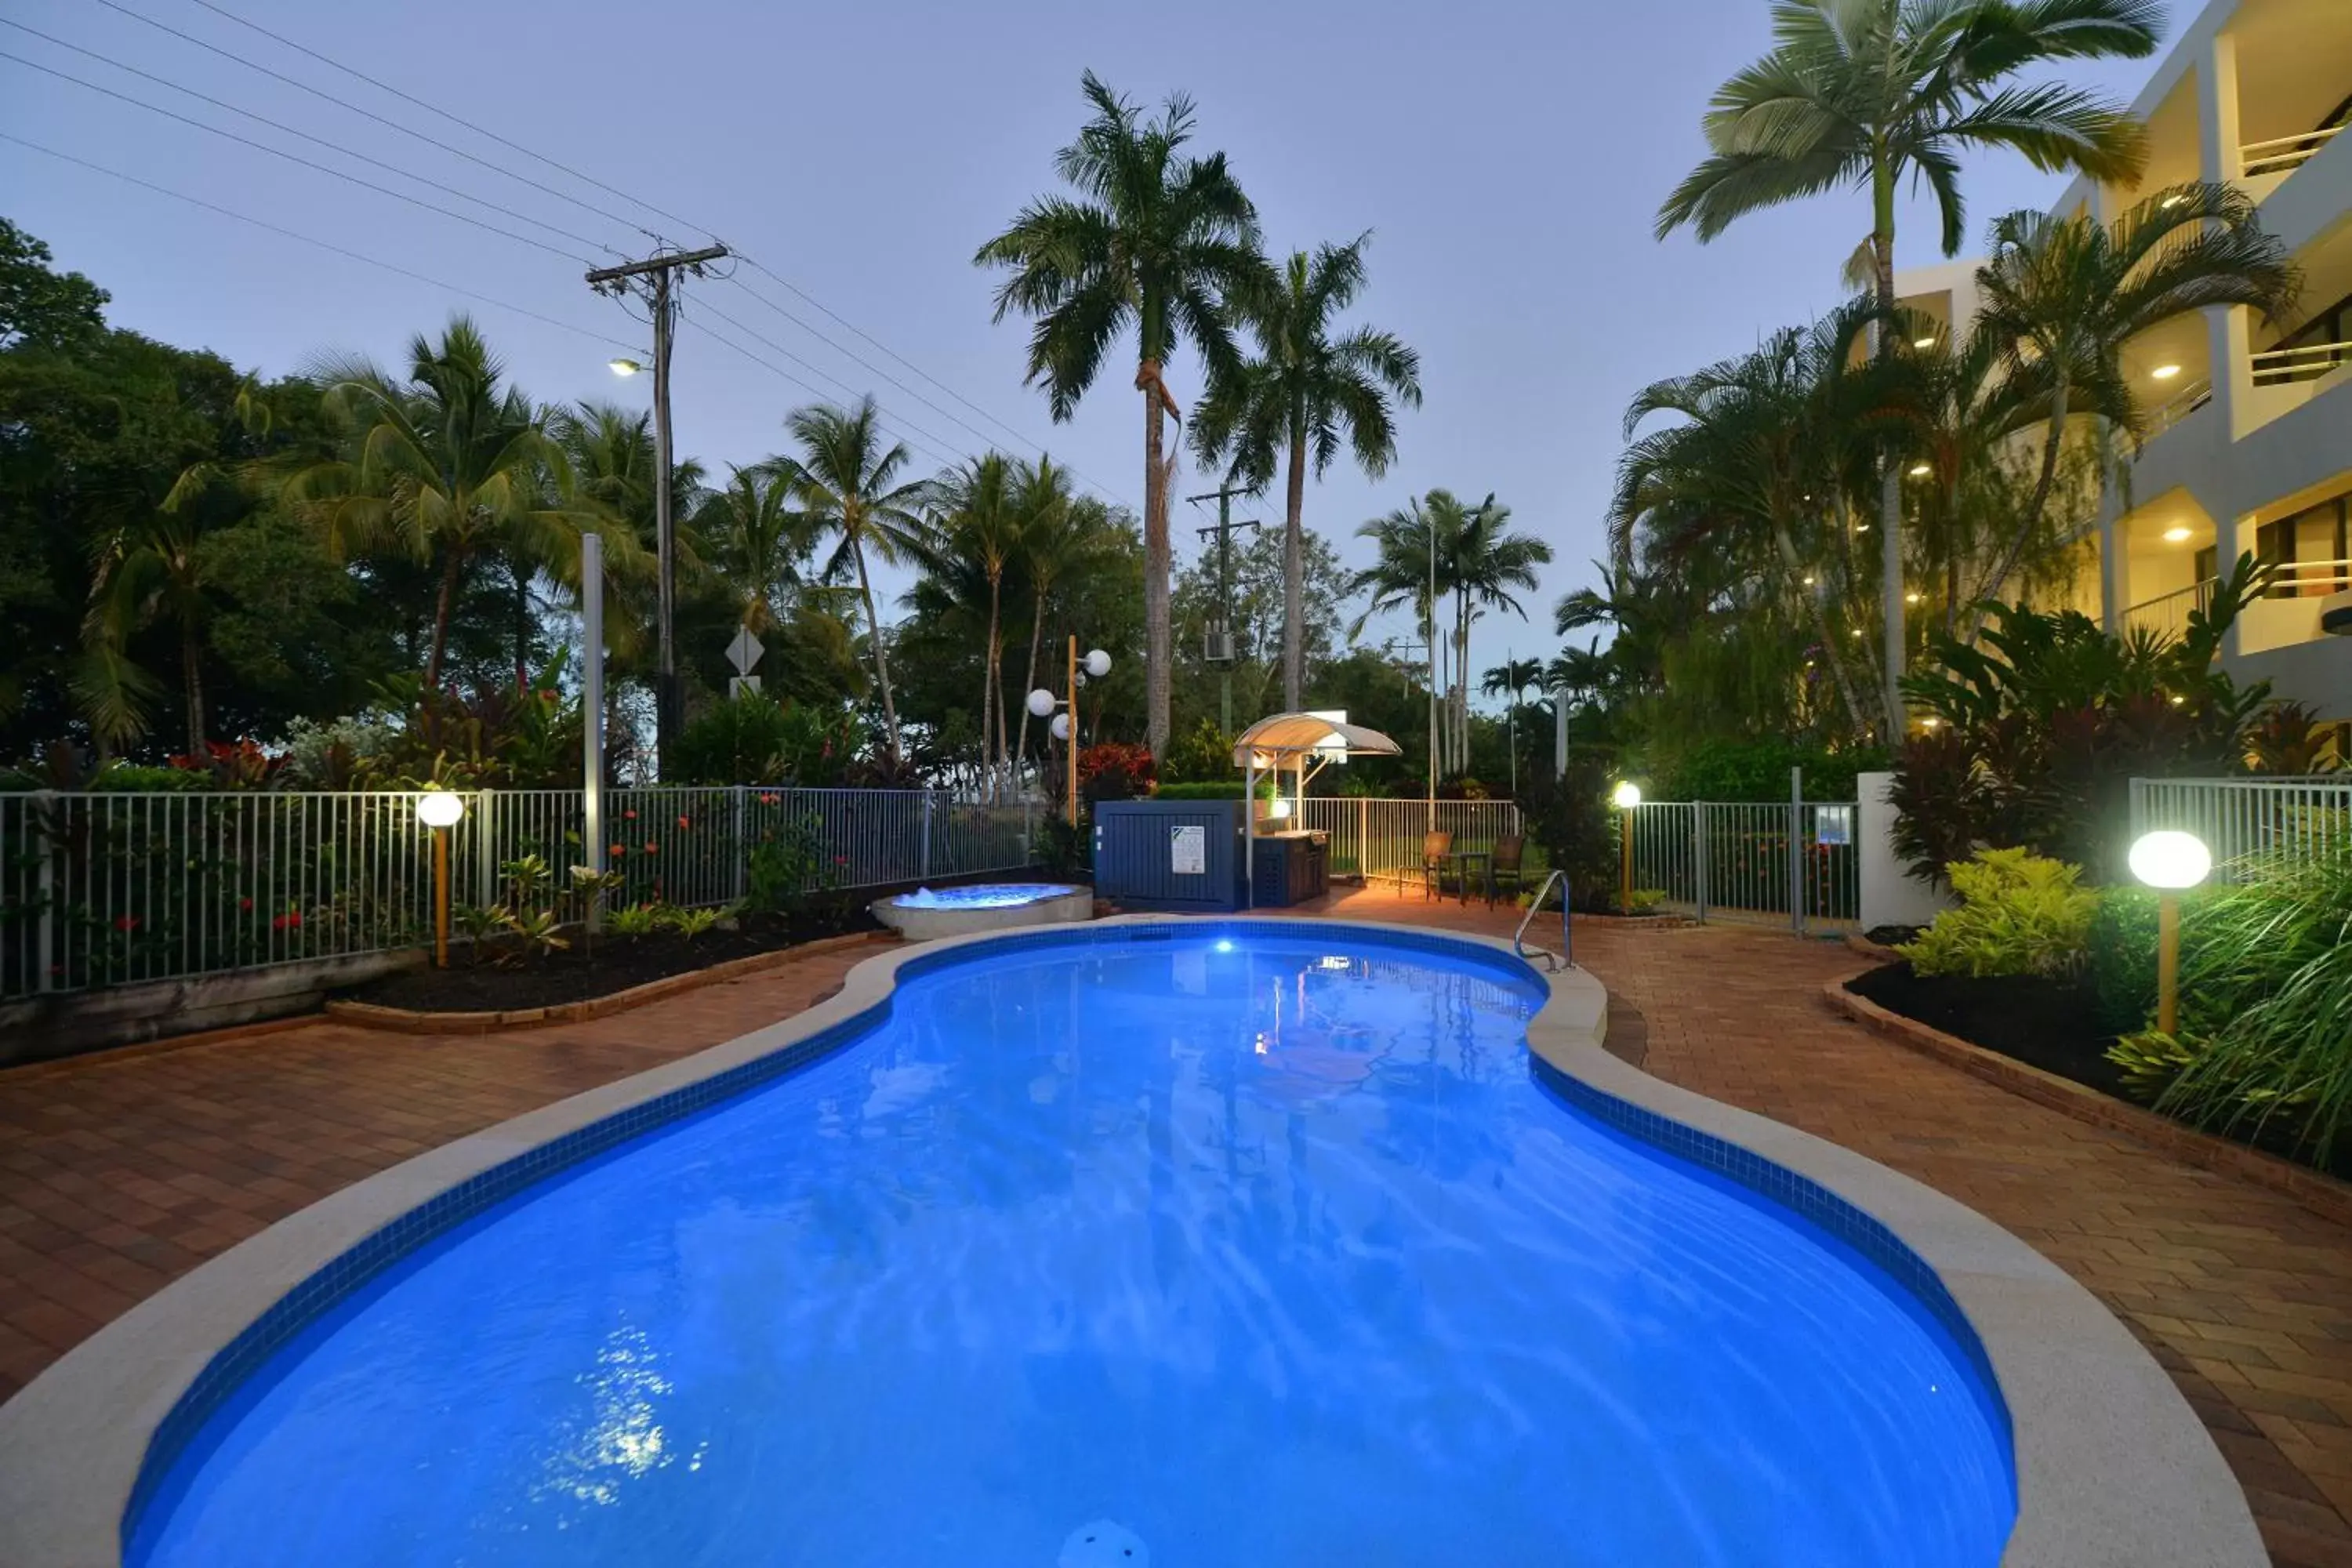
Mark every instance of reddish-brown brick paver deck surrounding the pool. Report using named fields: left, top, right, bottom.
left=0, top=893, right=2352, bottom=1568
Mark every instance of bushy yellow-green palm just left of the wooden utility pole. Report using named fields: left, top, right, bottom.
left=285, top=315, right=593, bottom=689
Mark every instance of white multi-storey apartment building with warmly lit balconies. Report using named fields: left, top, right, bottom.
left=1898, top=0, right=2352, bottom=734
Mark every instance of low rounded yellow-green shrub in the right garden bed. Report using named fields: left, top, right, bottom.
left=1896, top=848, right=2098, bottom=980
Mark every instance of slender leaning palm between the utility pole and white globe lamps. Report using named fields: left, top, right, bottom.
left=783, top=395, right=929, bottom=767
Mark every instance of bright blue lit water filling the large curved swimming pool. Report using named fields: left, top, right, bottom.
left=132, top=926, right=2013, bottom=1568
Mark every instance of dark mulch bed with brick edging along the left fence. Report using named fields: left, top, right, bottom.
left=343, top=900, right=882, bottom=1013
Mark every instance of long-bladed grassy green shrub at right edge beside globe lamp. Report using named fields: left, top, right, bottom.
left=2110, top=846, right=2352, bottom=1166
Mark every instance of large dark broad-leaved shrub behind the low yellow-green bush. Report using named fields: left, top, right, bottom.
left=1893, top=555, right=2270, bottom=881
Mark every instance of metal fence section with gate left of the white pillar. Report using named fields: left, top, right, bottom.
left=1616, top=801, right=1860, bottom=931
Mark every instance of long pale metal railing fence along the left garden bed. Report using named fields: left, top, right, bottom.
left=0, top=785, right=1035, bottom=999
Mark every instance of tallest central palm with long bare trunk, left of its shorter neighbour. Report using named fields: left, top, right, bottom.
left=974, top=71, right=1263, bottom=757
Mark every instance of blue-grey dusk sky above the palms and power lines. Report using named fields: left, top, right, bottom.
left=0, top=0, right=2183, bottom=700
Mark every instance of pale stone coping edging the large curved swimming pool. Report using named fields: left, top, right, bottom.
left=0, top=914, right=2267, bottom=1568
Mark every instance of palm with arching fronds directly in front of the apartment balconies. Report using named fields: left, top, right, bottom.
left=1976, top=183, right=2300, bottom=597
